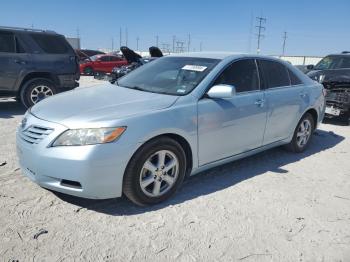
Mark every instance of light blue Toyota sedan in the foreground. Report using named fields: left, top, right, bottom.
left=17, top=53, right=325, bottom=205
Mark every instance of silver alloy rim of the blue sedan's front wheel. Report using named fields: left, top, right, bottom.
left=140, top=150, right=179, bottom=197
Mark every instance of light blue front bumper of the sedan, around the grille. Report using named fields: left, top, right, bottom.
left=16, top=115, right=133, bottom=199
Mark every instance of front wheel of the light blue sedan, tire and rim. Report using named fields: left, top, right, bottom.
left=123, top=137, right=186, bottom=206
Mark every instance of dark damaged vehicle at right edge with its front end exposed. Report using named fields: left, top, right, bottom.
left=307, top=52, right=350, bottom=122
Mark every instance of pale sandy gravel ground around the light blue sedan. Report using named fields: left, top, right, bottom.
left=0, top=78, right=350, bottom=262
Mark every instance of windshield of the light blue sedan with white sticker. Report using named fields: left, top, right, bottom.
left=117, top=57, right=220, bottom=95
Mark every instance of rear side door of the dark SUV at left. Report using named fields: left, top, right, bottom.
left=0, top=31, right=30, bottom=92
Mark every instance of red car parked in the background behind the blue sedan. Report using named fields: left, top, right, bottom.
left=80, top=55, right=128, bottom=75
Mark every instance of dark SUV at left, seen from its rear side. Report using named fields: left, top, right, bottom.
left=0, top=26, right=79, bottom=107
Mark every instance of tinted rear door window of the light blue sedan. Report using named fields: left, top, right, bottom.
left=259, top=60, right=290, bottom=88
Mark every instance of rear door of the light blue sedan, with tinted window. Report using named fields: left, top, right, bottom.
left=258, top=60, right=308, bottom=145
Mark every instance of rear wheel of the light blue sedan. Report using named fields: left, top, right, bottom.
left=287, top=113, right=315, bottom=153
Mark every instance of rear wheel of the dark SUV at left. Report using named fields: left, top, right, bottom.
left=20, top=78, right=57, bottom=108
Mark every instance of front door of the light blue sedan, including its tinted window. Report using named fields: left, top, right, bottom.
left=198, top=59, right=266, bottom=165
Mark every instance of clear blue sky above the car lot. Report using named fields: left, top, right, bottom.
left=0, top=0, right=350, bottom=56
